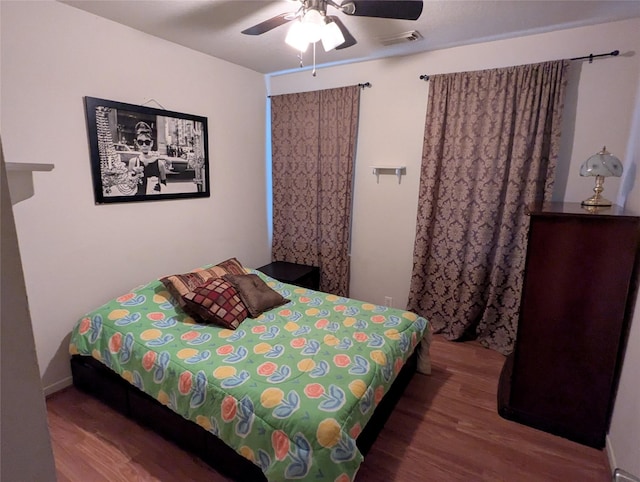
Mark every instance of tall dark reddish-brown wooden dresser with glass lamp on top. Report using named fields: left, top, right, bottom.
left=498, top=203, right=640, bottom=448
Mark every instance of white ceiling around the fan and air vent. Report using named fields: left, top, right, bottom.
left=59, top=0, right=640, bottom=74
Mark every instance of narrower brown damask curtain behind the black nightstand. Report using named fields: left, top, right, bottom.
left=271, top=85, right=360, bottom=296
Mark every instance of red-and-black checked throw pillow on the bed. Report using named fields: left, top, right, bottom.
left=182, top=278, right=248, bottom=330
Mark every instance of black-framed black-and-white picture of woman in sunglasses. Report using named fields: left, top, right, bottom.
left=84, top=97, right=211, bottom=204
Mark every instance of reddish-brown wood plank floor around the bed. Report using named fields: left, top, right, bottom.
left=47, top=336, right=611, bottom=482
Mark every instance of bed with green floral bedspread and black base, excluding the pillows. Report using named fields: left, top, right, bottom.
left=70, top=263, right=429, bottom=482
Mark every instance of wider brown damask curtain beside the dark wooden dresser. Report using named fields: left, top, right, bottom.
left=408, top=61, right=568, bottom=354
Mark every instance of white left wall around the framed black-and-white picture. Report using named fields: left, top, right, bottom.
left=0, top=1, right=270, bottom=392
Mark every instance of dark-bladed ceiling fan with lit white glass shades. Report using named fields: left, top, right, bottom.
left=242, top=0, right=422, bottom=51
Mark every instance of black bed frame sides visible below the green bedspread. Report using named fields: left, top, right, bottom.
left=71, top=350, right=417, bottom=481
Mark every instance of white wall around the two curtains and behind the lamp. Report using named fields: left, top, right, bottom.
left=269, top=19, right=640, bottom=475
